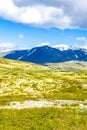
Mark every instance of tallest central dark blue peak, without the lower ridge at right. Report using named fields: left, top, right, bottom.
left=5, top=46, right=65, bottom=64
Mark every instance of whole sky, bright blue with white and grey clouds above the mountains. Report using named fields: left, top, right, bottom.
left=0, top=0, right=87, bottom=51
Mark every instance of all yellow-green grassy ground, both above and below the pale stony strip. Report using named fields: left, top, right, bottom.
left=0, top=58, right=87, bottom=130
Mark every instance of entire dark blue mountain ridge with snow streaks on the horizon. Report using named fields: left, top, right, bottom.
left=4, top=46, right=87, bottom=65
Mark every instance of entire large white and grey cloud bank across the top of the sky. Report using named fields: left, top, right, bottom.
left=0, top=0, right=87, bottom=29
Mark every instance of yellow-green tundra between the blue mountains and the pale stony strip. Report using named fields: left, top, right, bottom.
left=0, top=58, right=87, bottom=105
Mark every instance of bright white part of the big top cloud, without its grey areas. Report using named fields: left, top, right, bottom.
left=0, top=0, right=70, bottom=28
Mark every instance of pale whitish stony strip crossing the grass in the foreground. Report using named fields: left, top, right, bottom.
left=0, top=100, right=87, bottom=109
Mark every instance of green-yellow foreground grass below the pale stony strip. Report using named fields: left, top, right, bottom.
left=0, top=108, right=87, bottom=130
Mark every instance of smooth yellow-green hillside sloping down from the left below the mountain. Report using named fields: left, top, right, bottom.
left=0, top=58, right=48, bottom=71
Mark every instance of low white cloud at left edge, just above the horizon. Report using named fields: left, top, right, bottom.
left=0, top=42, right=17, bottom=52
